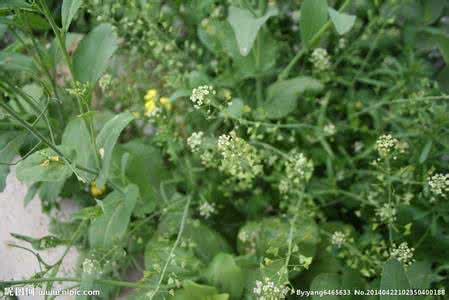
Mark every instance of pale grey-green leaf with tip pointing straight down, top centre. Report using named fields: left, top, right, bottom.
left=228, top=6, right=277, bottom=56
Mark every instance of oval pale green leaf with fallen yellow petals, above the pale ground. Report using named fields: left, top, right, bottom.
left=16, top=146, right=75, bottom=184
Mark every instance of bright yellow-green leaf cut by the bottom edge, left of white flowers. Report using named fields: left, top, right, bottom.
left=168, top=281, right=229, bottom=300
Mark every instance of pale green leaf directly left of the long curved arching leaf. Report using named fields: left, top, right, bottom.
left=62, top=117, right=95, bottom=181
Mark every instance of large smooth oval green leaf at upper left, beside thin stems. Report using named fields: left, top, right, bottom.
left=73, top=24, right=118, bottom=85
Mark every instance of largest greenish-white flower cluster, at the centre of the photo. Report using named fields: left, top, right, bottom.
left=217, top=131, right=263, bottom=189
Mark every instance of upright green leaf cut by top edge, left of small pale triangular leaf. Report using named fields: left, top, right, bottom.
left=299, top=0, right=328, bottom=47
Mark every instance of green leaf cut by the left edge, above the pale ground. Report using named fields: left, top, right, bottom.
left=0, top=132, right=26, bottom=192
